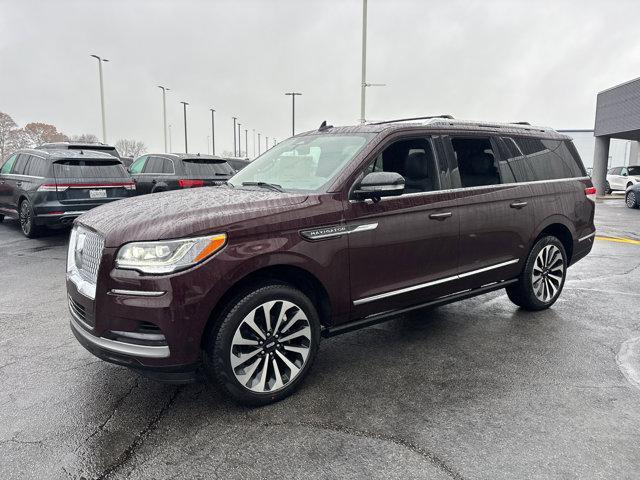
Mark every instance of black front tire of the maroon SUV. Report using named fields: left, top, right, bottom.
left=204, top=283, right=320, bottom=406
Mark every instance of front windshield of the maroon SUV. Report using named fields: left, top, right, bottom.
left=229, top=133, right=375, bottom=191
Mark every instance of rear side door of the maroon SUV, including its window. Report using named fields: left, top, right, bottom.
left=446, top=135, right=534, bottom=289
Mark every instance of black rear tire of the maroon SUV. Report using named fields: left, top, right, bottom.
left=506, top=235, right=567, bottom=311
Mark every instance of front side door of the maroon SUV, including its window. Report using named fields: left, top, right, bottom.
left=345, top=136, right=460, bottom=318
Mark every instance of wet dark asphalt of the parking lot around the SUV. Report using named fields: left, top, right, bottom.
left=0, top=200, right=640, bottom=479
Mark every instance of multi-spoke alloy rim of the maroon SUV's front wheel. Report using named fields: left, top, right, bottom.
left=230, top=300, right=311, bottom=393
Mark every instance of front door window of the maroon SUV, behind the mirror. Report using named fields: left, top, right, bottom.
left=366, top=138, right=439, bottom=193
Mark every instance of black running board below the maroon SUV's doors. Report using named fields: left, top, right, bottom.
left=322, top=279, right=518, bottom=338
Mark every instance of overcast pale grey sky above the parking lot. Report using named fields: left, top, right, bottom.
left=0, top=0, right=640, bottom=153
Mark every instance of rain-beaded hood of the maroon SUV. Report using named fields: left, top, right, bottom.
left=77, top=186, right=307, bottom=247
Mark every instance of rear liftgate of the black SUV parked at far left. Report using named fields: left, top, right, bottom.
left=53, top=158, right=134, bottom=205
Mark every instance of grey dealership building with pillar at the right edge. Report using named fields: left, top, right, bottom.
left=588, top=78, right=640, bottom=194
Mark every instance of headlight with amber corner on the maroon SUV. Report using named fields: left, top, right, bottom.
left=116, top=233, right=227, bottom=274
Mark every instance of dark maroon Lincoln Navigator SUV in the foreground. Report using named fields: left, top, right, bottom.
left=67, top=117, right=595, bottom=405
